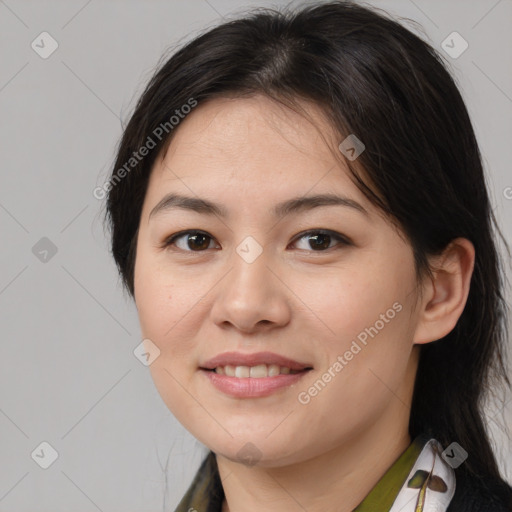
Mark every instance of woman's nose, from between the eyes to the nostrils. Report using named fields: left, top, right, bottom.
left=211, top=245, right=292, bottom=334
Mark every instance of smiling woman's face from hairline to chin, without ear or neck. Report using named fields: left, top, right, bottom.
left=135, top=96, right=419, bottom=467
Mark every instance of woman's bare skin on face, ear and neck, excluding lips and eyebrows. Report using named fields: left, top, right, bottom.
left=134, top=96, right=474, bottom=512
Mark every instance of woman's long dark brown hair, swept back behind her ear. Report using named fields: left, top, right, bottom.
left=102, top=1, right=510, bottom=498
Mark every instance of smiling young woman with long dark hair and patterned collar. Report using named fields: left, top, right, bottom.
left=102, top=1, right=512, bottom=512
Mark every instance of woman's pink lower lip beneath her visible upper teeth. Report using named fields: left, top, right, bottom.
left=200, top=369, right=309, bottom=398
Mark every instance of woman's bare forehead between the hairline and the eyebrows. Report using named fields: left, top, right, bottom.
left=142, top=95, right=364, bottom=214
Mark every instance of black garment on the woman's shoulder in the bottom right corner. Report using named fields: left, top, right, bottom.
left=447, top=471, right=512, bottom=512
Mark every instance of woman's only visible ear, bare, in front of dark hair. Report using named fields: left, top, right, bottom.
left=413, top=238, right=475, bottom=344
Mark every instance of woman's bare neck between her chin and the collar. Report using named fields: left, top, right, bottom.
left=217, top=412, right=411, bottom=512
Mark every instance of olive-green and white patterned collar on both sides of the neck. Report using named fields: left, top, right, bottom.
left=175, top=434, right=455, bottom=512
